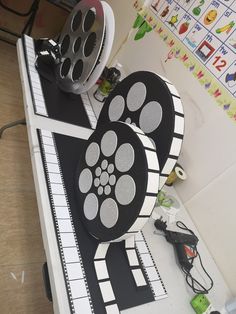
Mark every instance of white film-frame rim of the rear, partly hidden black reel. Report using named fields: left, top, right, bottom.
left=158, top=74, right=184, bottom=190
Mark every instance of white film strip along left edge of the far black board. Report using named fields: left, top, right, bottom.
left=23, top=35, right=48, bottom=117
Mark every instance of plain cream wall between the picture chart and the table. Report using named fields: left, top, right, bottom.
left=104, top=0, right=236, bottom=295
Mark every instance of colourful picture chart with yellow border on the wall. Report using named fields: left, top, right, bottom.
left=134, top=0, right=236, bottom=121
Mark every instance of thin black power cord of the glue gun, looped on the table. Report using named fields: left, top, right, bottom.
left=176, top=221, right=214, bottom=294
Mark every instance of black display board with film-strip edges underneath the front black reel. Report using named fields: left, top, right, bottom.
left=37, top=129, right=167, bottom=314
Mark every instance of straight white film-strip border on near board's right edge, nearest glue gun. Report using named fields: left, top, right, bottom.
left=135, top=231, right=168, bottom=300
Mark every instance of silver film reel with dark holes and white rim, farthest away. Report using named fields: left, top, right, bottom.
left=56, top=0, right=114, bottom=94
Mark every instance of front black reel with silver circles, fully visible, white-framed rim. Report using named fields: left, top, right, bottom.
left=75, top=122, right=159, bottom=242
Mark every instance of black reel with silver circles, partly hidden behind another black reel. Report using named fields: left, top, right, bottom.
left=98, top=71, right=184, bottom=189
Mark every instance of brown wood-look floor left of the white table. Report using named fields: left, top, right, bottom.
left=0, top=1, right=67, bottom=314
